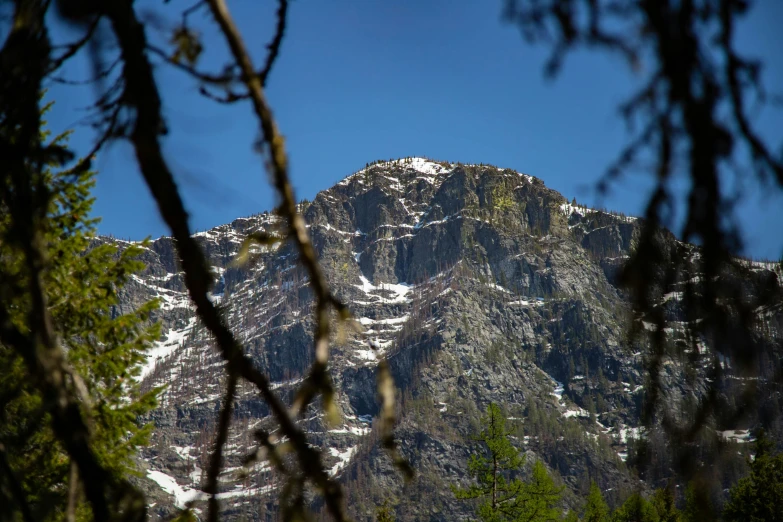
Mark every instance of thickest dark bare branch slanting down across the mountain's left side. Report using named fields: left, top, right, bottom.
left=83, top=0, right=346, bottom=520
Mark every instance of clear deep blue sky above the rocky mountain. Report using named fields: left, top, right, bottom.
left=49, top=0, right=783, bottom=259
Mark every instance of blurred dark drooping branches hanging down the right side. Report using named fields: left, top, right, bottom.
left=504, top=0, right=783, bottom=482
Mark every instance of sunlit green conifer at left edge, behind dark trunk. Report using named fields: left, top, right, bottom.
left=0, top=106, right=159, bottom=520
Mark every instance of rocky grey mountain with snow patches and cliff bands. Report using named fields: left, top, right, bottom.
left=112, top=158, right=783, bottom=521
